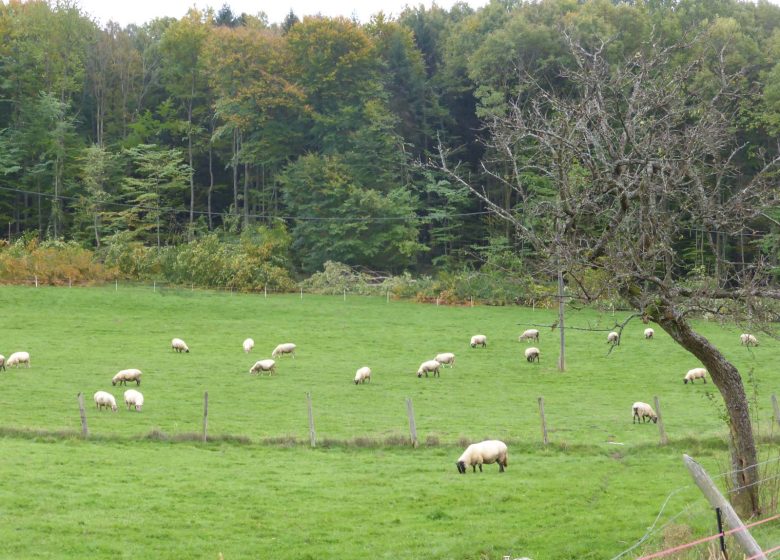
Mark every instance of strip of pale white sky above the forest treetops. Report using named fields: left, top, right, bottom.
left=77, top=0, right=488, bottom=26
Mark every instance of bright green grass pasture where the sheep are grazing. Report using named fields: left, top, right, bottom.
left=0, top=286, right=780, bottom=560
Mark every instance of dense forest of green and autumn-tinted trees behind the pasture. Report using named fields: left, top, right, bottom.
left=0, top=0, right=780, bottom=274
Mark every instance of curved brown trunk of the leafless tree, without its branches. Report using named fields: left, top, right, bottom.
left=652, top=302, right=760, bottom=516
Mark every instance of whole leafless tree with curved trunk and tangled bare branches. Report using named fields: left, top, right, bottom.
left=437, top=35, right=780, bottom=512
